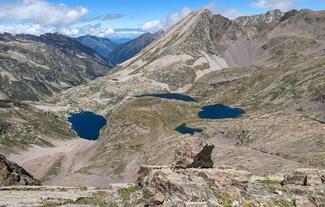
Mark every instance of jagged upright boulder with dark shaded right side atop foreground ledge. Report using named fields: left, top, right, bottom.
left=173, top=142, right=215, bottom=169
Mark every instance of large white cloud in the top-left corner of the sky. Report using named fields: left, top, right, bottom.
left=0, top=0, right=88, bottom=26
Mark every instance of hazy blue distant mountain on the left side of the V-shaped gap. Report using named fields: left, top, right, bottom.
left=76, top=35, right=118, bottom=57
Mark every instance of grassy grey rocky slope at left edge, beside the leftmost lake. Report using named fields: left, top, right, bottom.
left=0, top=100, right=77, bottom=155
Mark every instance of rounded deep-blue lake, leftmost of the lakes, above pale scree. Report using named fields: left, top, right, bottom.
left=68, top=112, right=107, bottom=140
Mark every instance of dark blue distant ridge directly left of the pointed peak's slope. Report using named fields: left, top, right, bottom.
left=109, top=32, right=161, bottom=64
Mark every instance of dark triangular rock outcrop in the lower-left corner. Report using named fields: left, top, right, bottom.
left=0, top=155, right=41, bottom=186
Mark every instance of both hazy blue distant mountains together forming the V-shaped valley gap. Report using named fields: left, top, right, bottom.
left=76, top=32, right=161, bottom=64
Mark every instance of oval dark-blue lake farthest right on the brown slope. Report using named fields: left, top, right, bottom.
left=198, top=104, right=245, bottom=119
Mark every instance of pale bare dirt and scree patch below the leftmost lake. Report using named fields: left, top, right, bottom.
left=9, top=139, right=111, bottom=187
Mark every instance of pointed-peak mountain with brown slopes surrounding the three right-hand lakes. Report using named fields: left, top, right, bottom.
left=54, top=9, right=325, bottom=182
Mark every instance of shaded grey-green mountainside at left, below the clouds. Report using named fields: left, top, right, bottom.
left=0, top=33, right=113, bottom=101
